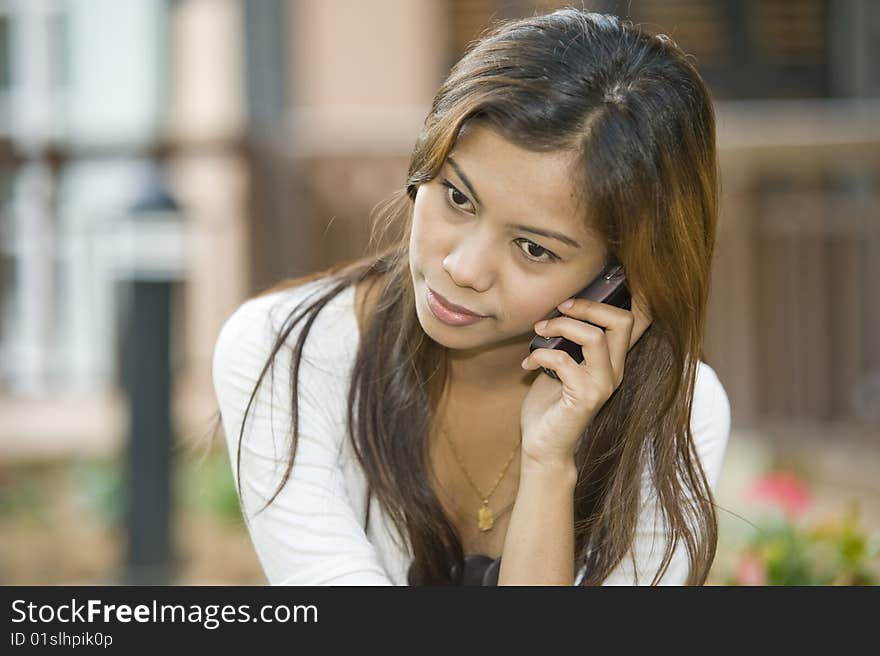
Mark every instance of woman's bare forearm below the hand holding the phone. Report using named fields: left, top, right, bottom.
left=498, top=460, right=577, bottom=585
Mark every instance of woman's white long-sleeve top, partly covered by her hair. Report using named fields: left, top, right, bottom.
left=212, top=278, right=730, bottom=585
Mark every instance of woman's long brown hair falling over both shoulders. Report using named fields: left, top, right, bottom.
left=213, top=8, right=719, bottom=585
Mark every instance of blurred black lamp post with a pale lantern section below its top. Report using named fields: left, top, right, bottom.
left=118, top=165, right=185, bottom=585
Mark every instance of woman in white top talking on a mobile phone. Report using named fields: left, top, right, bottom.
left=213, top=9, right=730, bottom=585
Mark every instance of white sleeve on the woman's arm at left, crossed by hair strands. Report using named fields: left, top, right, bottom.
left=212, top=294, right=392, bottom=585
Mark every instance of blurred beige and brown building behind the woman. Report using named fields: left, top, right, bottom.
left=0, top=0, right=880, bottom=453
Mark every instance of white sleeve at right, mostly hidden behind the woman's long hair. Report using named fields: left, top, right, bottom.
left=602, top=361, right=730, bottom=585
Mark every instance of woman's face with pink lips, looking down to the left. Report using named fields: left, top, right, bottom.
left=409, top=125, right=607, bottom=349
